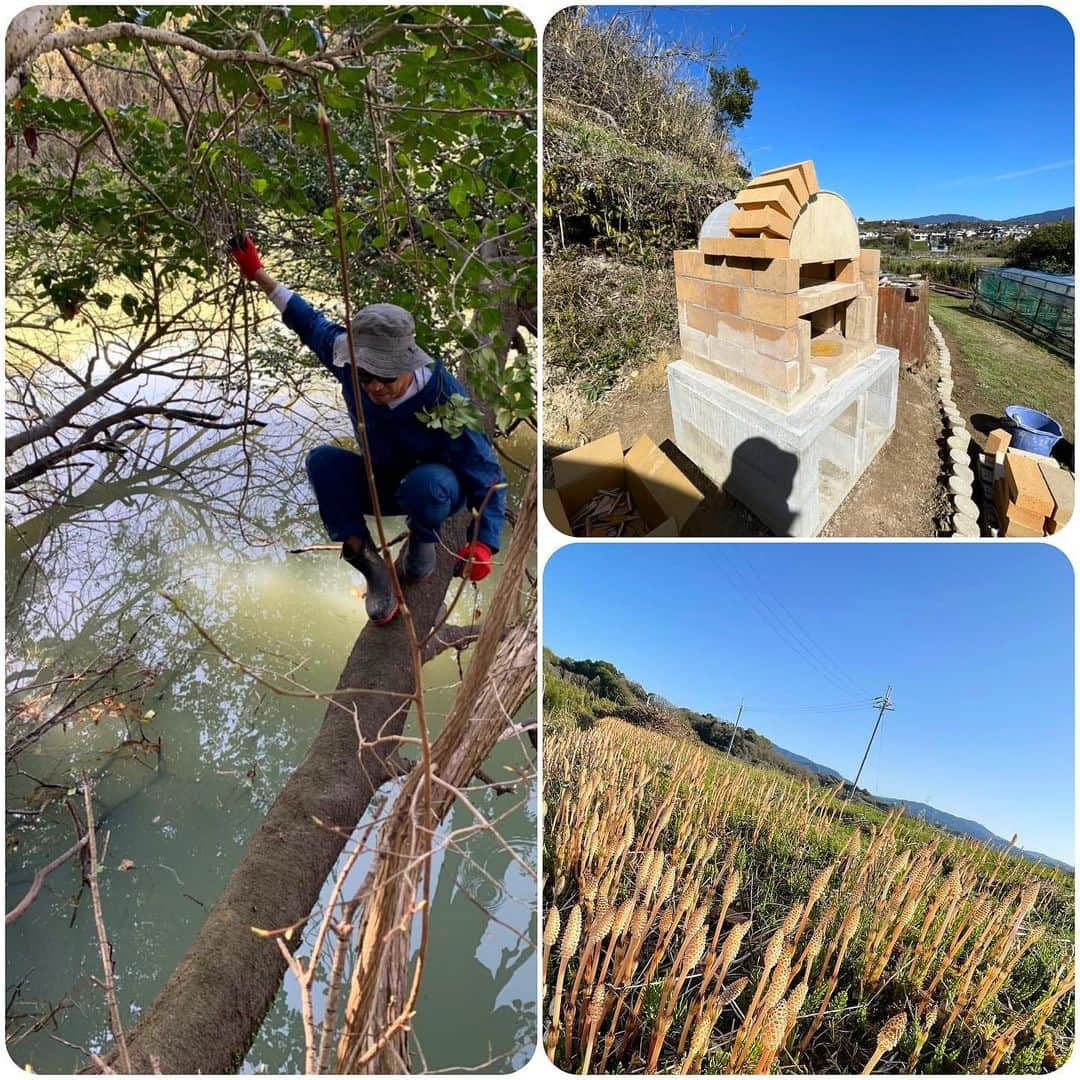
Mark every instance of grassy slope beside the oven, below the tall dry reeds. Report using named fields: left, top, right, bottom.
left=543, top=90, right=742, bottom=407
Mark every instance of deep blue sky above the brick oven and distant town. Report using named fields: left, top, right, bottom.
left=604, top=5, right=1075, bottom=218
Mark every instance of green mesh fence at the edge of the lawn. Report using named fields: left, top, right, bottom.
left=971, top=268, right=1075, bottom=360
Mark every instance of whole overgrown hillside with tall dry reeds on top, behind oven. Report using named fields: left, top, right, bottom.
left=543, top=8, right=745, bottom=397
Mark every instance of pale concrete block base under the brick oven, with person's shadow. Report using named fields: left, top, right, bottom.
left=667, top=346, right=900, bottom=537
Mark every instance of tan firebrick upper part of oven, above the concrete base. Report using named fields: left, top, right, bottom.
left=675, top=161, right=880, bottom=409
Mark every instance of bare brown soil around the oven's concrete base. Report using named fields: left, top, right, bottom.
left=544, top=347, right=948, bottom=537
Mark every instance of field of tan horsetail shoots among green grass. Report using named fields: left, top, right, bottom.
left=543, top=718, right=1075, bottom=1074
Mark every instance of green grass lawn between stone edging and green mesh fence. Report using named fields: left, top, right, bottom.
left=930, top=293, right=1076, bottom=442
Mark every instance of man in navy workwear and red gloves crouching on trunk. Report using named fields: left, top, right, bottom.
left=229, top=233, right=505, bottom=625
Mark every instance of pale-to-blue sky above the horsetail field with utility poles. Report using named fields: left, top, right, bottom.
left=543, top=543, right=1075, bottom=863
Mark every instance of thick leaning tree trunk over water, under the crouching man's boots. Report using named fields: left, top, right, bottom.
left=113, top=514, right=468, bottom=1074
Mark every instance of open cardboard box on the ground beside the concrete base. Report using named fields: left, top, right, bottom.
left=543, top=431, right=705, bottom=537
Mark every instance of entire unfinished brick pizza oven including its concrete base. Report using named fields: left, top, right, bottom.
left=667, top=161, right=900, bottom=536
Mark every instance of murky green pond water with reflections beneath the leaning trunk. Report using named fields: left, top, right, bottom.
left=5, top=360, right=537, bottom=1072
